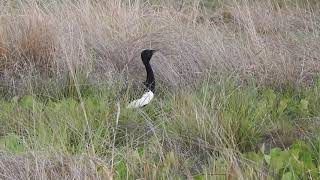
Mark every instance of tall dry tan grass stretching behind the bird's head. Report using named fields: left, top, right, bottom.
left=0, top=0, right=320, bottom=93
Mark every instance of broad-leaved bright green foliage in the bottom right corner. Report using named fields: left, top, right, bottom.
left=243, top=141, right=320, bottom=180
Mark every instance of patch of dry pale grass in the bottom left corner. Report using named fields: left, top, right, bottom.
left=0, top=152, right=112, bottom=180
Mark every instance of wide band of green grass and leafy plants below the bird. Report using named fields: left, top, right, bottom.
left=0, top=78, right=320, bottom=179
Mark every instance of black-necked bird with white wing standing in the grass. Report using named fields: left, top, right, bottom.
left=127, top=49, right=158, bottom=109
